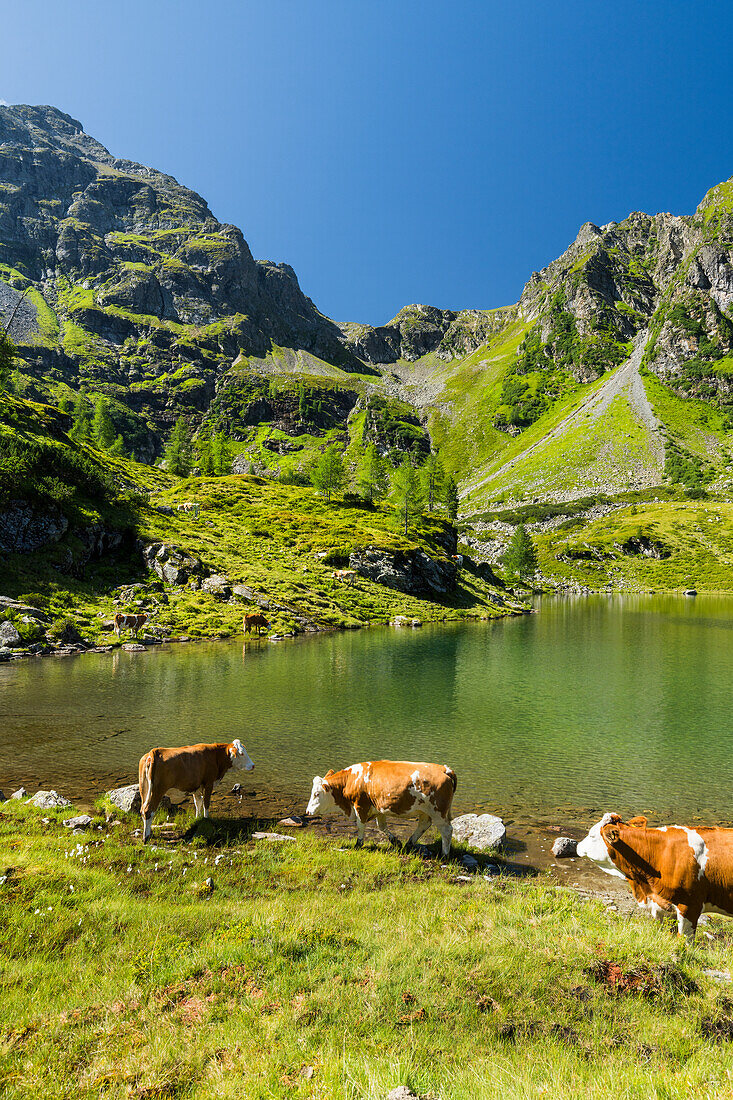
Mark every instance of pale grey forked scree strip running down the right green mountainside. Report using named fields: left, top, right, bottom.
left=460, top=329, right=664, bottom=497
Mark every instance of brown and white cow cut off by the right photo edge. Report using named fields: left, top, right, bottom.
left=578, top=814, right=733, bottom=939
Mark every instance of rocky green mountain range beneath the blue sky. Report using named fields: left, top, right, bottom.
left=0, top=106, right=733, bottom=598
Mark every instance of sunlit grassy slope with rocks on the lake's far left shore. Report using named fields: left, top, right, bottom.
left=0, top=398, right=510, bottom=642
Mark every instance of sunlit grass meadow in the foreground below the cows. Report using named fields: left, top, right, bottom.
left=0, top=803, right=733, bottom=1100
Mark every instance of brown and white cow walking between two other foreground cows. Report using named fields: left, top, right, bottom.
left=306, top=760, right=457, bottom=856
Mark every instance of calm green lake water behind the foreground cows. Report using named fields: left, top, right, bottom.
left=0, top=596, right=733, bottom=826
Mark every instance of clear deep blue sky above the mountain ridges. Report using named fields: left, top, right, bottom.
left=0, top=0, right=733, bottom=325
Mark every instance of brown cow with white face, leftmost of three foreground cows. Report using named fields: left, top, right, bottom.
left=138, top=738, right=254, bottom=844
